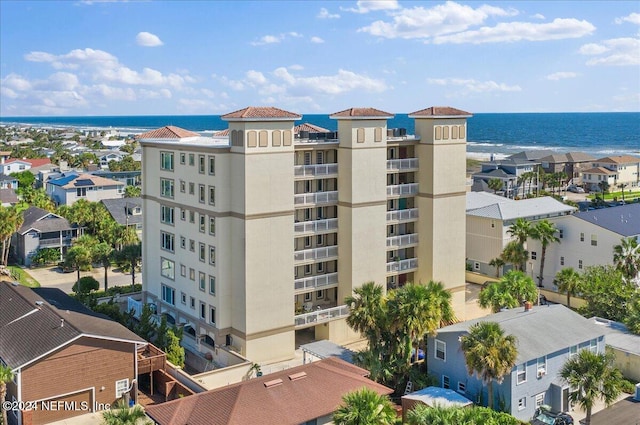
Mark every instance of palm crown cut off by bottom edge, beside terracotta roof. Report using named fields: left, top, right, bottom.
left=333, top=387, right=398, bottom=425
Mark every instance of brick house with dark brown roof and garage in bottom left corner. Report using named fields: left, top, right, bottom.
left=0, top=282, right=147, bottom=425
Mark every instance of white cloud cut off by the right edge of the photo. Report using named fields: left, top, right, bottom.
left=579, top=37, right=640, bottom=66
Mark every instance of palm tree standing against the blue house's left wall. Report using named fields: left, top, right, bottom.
left=460, top=322, right=518, bottom=408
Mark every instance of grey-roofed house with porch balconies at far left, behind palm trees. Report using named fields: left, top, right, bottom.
left=12, top=207, right=81, bottom=266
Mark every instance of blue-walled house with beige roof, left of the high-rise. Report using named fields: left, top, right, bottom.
left=47, top=173, right=124, bottom=205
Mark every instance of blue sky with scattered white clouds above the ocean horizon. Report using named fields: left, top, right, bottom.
left=0, top=0, right=640, bottom=116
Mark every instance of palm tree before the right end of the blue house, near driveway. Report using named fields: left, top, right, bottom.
left=560, top=349, right=622, bottom=425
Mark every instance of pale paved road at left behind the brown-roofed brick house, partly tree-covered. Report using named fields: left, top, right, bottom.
left=24, top=267, right=142, bottom=293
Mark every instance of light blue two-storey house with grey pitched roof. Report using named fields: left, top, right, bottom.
left=427, top=304, right=605, bottom=421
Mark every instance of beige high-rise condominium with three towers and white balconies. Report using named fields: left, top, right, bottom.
left=139, top=107, right=470, bottom=362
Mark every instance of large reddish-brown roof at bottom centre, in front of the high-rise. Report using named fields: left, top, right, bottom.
left=146, top=357, right=393, bottom=425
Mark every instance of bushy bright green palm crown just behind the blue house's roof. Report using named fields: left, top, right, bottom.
left=478, top=270, right=538, bottom=313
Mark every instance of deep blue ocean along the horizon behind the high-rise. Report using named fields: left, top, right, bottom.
left=0, top=112, right=640, bottom=157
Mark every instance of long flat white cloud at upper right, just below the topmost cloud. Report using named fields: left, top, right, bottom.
left=433, top=18, right=596, bottom=44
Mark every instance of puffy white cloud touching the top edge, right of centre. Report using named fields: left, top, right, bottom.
left=358, top=1, right=518, bottom=39
